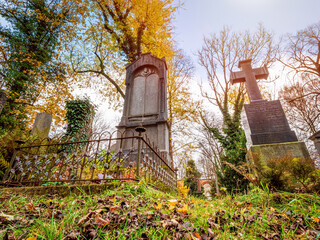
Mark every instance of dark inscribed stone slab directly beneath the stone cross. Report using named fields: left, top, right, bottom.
left=242, top=100, right=298, bottom=148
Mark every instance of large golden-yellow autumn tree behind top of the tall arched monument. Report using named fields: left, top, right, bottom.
left=70, top=0, right=180, bottom=100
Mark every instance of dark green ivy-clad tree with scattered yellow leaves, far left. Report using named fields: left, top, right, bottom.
left=0, top=0, right=68, bottom=134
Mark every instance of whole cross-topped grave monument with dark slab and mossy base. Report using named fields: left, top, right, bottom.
left=230, top=60, right=309, bottom=160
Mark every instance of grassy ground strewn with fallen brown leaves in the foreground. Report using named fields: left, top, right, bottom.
left=0, top=182, right=320, bottom=240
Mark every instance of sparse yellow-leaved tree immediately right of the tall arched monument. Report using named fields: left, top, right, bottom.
left=167, top=51, right=200, bottom=162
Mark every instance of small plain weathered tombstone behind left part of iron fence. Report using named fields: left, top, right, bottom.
left=31, top=112, right=52, bottom=139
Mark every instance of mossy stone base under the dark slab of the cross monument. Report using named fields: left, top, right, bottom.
left=247, top=142, right=310, bottom=165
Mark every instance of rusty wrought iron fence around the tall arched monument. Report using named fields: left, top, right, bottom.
left=1, top=132, right=176, bottom=186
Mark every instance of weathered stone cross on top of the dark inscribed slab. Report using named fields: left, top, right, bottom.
left=230, top=59, right=269, bottom=102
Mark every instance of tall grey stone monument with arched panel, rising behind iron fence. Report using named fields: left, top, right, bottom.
left=117, top=53, right=172, bottom=165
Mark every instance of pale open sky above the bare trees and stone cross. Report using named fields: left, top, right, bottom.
left=174, top=0, right=320, bottom=80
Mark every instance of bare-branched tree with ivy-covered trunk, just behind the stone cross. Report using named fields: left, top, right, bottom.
left=198, top=25, right=278, bottom=190
